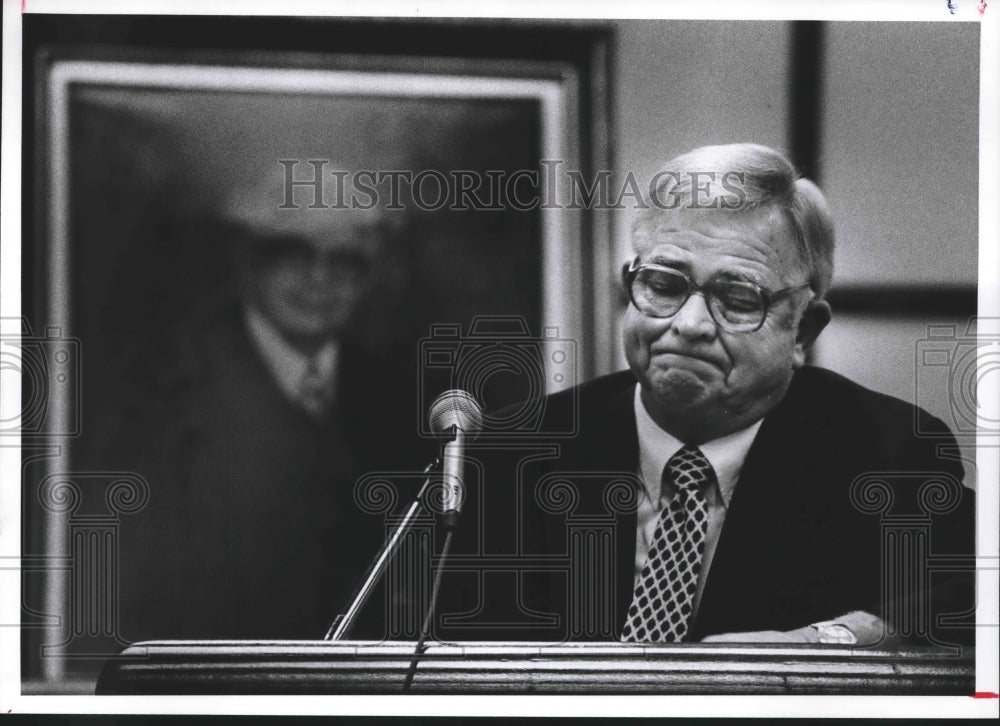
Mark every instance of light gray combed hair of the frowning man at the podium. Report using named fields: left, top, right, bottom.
left=632, top=144, right=834, bottom=298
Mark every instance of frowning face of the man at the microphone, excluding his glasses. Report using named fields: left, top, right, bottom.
left=624, top=210, right=825, bottom=444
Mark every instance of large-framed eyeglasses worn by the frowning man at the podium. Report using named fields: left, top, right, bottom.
left=622, top=257, right=809, bottom=333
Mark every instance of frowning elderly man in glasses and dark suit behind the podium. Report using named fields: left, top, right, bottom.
left=462, top=144, right=974, bottom=644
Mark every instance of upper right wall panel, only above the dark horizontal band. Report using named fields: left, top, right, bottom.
left=822, top=23, right=979, bottom=285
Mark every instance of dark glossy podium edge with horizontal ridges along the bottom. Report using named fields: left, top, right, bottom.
left=97, top=640, right=975, bottom=696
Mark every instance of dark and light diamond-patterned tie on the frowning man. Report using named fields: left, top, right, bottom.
left=622, top=446, right=715, bottom=643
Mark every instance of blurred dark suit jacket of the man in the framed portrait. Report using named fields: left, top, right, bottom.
left=87, top=306, right=434, bottom=641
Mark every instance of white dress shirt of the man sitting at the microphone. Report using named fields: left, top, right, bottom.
left=633, top=384, right=763, bottom=613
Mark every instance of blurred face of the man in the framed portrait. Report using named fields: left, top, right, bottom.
left=248, top=235, right=370, bottom=347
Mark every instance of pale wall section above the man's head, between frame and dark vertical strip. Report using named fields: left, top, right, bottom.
left=614, top=20, right=789, bottom=268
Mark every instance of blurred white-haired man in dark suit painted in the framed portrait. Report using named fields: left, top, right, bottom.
left=97, top=164, right=427, bottom=640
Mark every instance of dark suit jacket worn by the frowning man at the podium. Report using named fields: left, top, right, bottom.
left=444, top=367, right=974, bottom=642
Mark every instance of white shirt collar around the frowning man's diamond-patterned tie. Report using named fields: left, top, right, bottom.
left=634, top=384, right=764, bottom=507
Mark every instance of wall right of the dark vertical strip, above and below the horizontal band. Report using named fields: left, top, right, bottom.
left=815, top=23, right=979, bottom=485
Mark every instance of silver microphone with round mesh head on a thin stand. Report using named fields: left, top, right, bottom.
left=427, top=389, right=483, bottom=529
